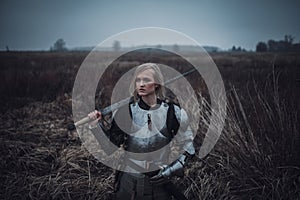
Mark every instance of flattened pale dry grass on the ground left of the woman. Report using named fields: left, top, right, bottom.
left=1, top=97, right=113, bottom=199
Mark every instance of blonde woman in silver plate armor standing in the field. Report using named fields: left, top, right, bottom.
left=89, top=63, right=195, bottom=199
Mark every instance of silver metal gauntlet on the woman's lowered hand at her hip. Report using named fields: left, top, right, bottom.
left=150, top=155, right=186, bottom=185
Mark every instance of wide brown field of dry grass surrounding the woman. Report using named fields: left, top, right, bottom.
left=0, top=52, right=300, bottom=200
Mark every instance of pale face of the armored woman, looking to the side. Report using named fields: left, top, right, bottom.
left=135, top=69, right=157, bottom=97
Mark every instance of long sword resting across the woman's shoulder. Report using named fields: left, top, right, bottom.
left=68, top=68, right=196, bottom=130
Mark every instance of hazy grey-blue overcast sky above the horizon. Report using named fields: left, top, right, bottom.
left=0, top=0, right=300, bottom=50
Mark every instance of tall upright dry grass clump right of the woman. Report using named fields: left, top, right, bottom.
left=180, top=65, right=300, bottom=199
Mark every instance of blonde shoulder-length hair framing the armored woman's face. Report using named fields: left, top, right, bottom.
left=129, top=63, right=165, bottom=101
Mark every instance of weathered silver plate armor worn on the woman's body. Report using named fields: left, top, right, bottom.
left=90, top=99, right=195, bottom=199
